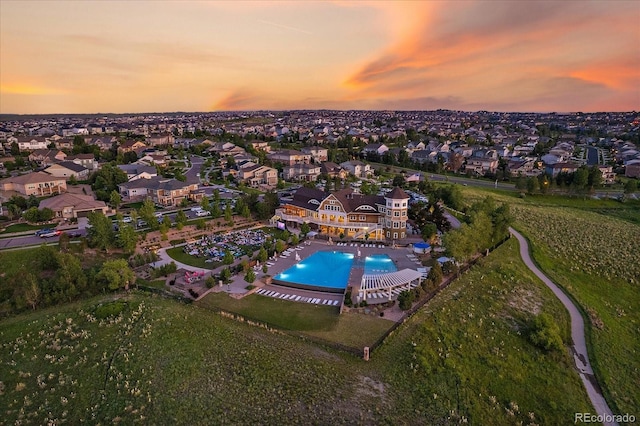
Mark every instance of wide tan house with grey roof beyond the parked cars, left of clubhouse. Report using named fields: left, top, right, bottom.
left=118, top=176, right=198, bottom=206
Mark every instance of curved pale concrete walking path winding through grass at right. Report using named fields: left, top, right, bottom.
left=509, top=228, right=617, bottom=425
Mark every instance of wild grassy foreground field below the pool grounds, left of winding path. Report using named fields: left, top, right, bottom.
left=0, top=241, right=589, bottom=425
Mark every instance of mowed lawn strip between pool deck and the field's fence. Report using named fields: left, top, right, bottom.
left=197, top=293, right=393, bottom=349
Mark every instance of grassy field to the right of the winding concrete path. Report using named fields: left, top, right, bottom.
left=464, top=188, right=640, bottom=413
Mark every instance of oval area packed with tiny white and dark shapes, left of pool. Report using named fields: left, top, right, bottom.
left=183, top=230, right=267, bottom=262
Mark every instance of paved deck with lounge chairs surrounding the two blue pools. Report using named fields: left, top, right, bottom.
left=251, top=240, right=420, bottom=303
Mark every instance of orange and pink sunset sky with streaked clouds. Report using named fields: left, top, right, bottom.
left=0, top=0, right=640, bottom=113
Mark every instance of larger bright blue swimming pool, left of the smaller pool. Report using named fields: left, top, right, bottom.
left=273, top=251, right=354, bottom=293
